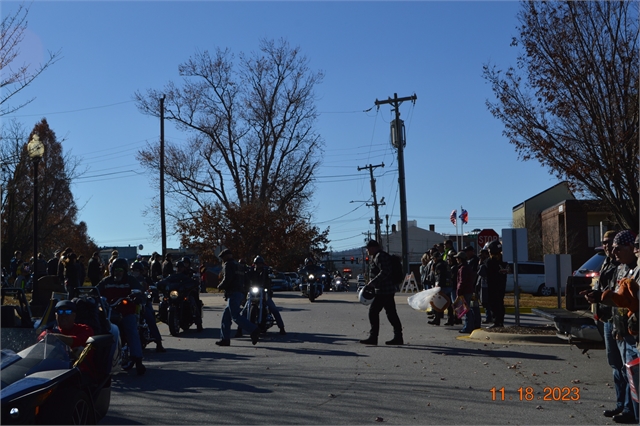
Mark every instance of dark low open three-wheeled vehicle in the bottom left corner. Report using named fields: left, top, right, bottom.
left=0, top=289, right=120, bottom=424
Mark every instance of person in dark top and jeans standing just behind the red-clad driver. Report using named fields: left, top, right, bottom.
left=98, top=257, right=147, bottom=375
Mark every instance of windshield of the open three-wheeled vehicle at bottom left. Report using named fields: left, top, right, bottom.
left=1, top=334, right=72, bottom=388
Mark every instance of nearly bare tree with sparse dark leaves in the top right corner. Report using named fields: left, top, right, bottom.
left=484, top=0, right=639, bottom=230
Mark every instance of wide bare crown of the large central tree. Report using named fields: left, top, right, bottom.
left=135, top=40, right=323, bottom=260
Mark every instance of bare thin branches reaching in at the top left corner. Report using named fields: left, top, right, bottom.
left=0, top=5, right=60, bottom=117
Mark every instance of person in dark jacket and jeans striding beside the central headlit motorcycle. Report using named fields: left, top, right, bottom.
left=215, top=249, right=260, bottom=346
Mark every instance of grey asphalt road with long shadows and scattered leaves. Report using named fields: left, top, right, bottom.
left=101, top=292, right=615, bottom=425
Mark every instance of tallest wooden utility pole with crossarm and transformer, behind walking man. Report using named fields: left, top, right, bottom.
left=376, top=93, right=418, bottom=274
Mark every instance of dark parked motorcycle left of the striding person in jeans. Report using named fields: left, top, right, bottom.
left=157, top=277, right=203, bottom=336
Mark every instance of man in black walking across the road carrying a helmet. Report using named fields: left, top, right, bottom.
left=360, top=240, right=404, bottom=345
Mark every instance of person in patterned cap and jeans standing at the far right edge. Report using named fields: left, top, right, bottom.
left=601, top=230, right=640, bottom=424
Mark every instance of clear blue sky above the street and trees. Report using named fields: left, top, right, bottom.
left=1, top=1, right=558, bottom=254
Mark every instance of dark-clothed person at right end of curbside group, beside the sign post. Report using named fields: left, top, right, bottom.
left=485, top=240, right=507, bottom=328
